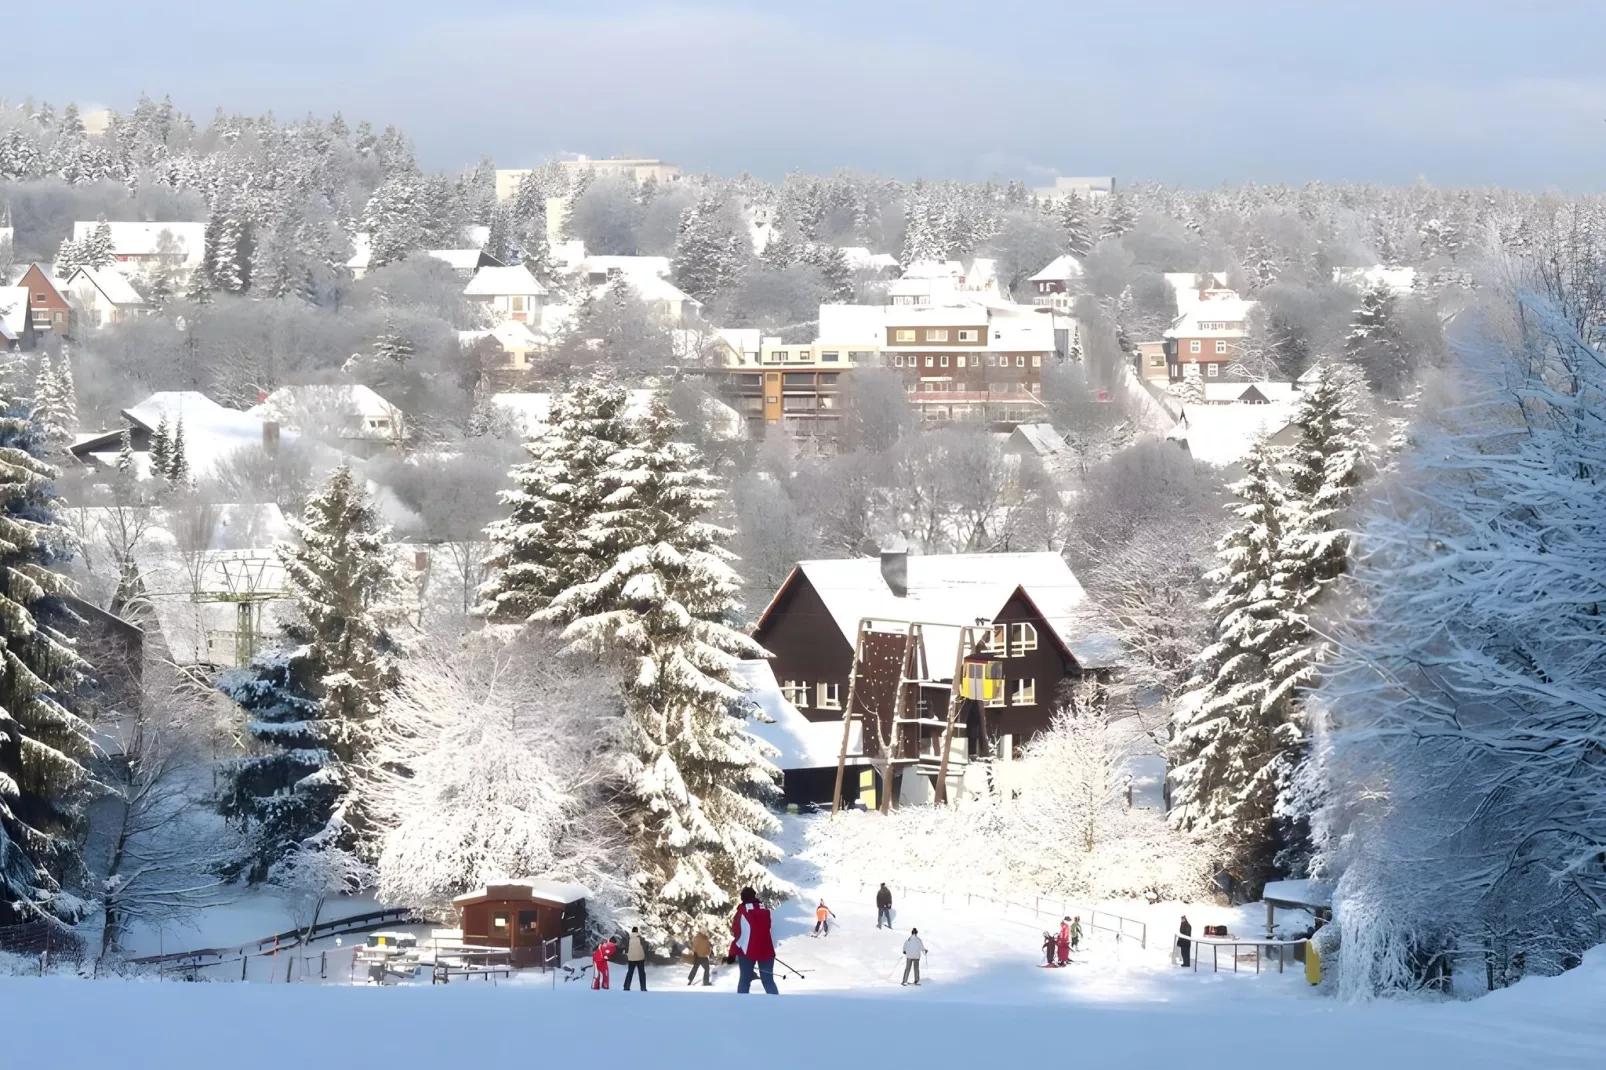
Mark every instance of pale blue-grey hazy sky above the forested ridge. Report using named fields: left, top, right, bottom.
left=12, top=0, right=1606, bottom=190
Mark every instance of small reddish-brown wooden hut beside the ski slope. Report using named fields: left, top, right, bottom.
left=451, top=880, right=591, bottom=966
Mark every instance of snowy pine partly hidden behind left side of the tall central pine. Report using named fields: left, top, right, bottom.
left=475, top=382, right=631, bottom=623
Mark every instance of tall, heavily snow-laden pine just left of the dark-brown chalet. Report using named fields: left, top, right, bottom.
left=536, top=400, right=787, bottom=941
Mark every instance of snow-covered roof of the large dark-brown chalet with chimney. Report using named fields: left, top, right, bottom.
left=760, top=551, right=1121, bottom=673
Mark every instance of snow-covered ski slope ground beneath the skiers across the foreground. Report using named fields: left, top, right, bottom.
left=0, top=819, right=1606, bottom=1070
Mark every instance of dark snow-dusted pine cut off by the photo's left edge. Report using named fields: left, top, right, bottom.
left=0, top=353, right=92, bottom=924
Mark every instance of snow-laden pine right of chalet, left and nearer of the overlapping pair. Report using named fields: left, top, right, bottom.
left=1171, top=437, right=1314, bottom=885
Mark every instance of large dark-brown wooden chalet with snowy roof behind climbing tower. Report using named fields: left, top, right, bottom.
left=750, top=551, right=1116, bottom=803
